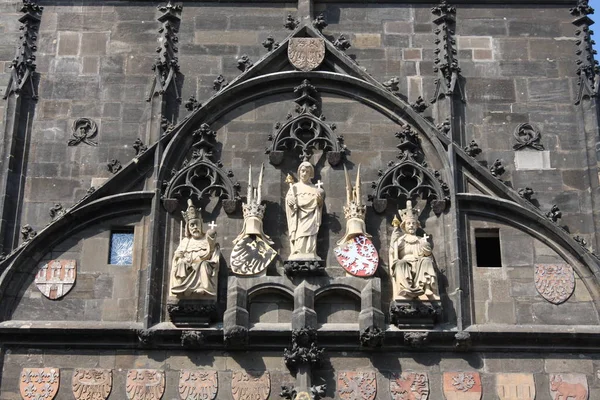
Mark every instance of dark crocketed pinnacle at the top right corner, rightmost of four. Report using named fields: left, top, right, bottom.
left=570, top=0, right=600, bottom=105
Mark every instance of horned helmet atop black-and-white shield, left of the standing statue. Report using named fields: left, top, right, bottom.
left=230, top=166, right=277, bottom=275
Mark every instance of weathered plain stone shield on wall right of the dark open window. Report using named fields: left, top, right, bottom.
left=534, top=264, right=575, bottom=304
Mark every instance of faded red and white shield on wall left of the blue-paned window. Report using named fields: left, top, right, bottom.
left=35, top=260, right=77, bottom=300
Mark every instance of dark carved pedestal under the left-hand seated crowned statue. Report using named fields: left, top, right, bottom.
left=167, top=297, right=217, bottom=328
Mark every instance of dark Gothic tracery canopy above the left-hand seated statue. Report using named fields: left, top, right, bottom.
left=163, top=124, right=239, bottom=214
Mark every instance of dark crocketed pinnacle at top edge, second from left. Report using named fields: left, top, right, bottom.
left=147, top=1, right=183, bottom=101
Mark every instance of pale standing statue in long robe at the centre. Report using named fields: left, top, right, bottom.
left=285, top=161, right=325, bottom=260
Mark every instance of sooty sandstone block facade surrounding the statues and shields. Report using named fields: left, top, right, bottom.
left=0, top=0, right=600, bottom=400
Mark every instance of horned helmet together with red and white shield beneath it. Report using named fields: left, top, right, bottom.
left=333, top=165, right=379, bottom=277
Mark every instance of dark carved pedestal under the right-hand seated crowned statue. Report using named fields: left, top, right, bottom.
left=390, top=300, right=442, bottom=328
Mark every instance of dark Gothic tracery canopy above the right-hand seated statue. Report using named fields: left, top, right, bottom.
left=369, top=125, right=450, bottom=215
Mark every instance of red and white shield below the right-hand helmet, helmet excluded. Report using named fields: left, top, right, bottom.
left=333, top=235, right=379, bottom=278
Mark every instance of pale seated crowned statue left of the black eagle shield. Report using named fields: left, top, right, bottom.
left=170, top=199, right=221, bottom=299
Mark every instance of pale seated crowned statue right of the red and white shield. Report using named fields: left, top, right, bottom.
left=389, top=200, right=440, bottom=300
